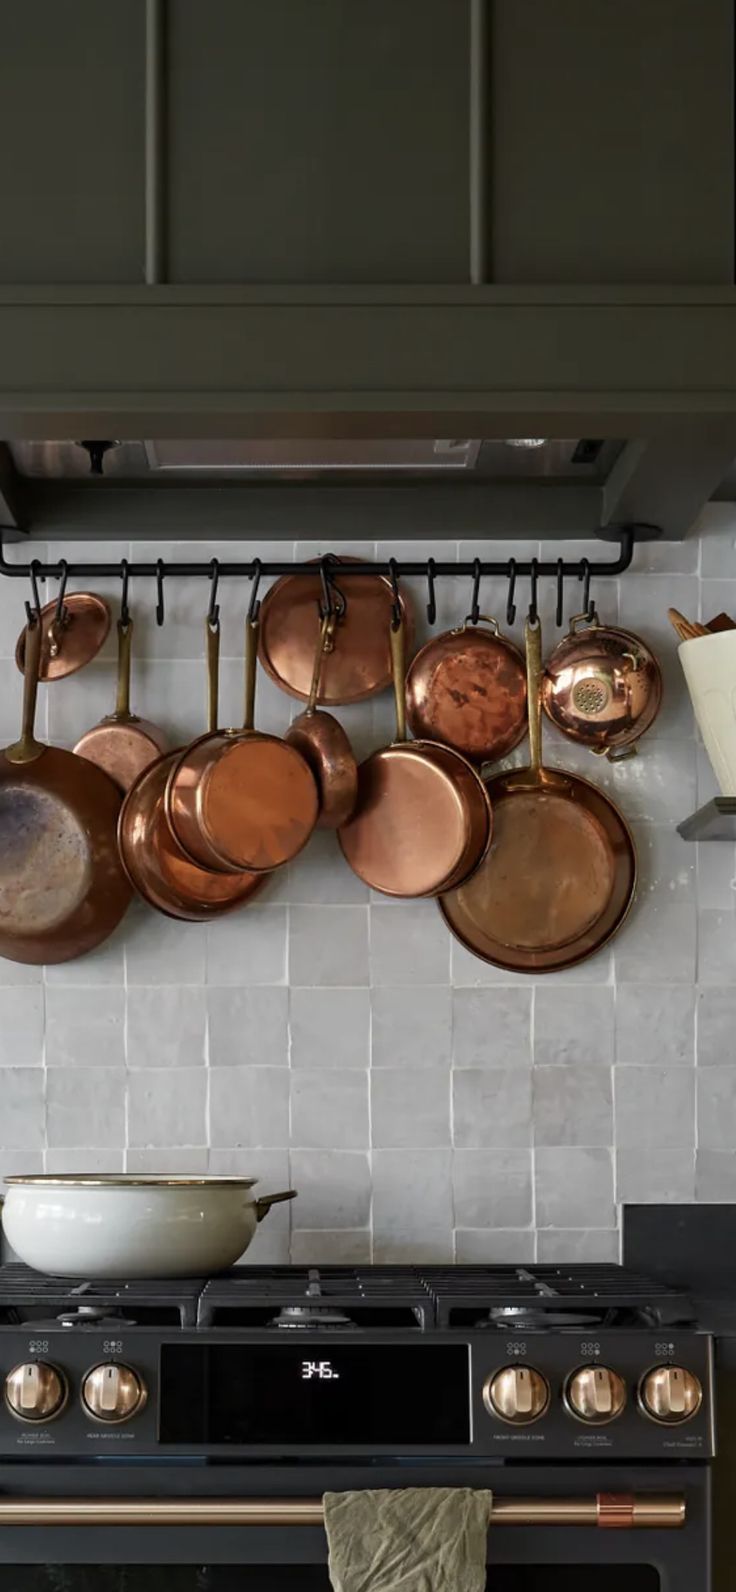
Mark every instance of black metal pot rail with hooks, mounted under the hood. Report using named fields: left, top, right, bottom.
left=0, top=524, right=640, bottom=624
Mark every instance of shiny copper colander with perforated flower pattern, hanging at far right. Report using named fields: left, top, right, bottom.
left=542, top=613, right=663, bottom=761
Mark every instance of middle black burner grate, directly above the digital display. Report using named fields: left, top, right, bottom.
left=199, top=1266, right=433, bottom=1328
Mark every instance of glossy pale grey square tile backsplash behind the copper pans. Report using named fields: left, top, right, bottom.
left=0, top=505, right=736, bottom=1262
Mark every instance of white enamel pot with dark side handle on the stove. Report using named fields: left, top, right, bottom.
left=3, top=1175, right=295, bottom=1282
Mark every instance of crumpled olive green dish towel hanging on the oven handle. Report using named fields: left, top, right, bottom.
left=323, top=1487, right=492, bottom=1592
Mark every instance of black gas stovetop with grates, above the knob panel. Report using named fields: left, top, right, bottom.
left=0, top=1264, right=696, bottom=1333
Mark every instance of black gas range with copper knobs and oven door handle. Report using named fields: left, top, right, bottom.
left=0, top=1266, right=714, bottom=1592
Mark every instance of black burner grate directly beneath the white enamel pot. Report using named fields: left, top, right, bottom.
left=0, top=1262, right=204, bottom=1326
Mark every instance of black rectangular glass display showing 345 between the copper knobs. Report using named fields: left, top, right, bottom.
left=159, top=1340, right=470, bottom=1449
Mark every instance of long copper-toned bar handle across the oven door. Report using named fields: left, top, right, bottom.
left=0, top=1493, right=687, bottom=1532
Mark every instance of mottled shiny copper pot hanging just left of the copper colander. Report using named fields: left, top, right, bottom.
left=406, top=619, right=526, bottom=763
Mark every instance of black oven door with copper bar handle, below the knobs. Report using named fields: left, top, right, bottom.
left=0, top=1461, right=711, bottom=1592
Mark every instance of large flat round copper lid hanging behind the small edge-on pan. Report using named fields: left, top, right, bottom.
left=258, top=559, right=414, bottom=707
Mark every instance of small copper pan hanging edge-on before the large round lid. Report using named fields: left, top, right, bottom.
left=284, top=615, right=358, bottom=829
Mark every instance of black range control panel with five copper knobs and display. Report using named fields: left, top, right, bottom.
left=0, top=1328, right=714, bottom=1461
